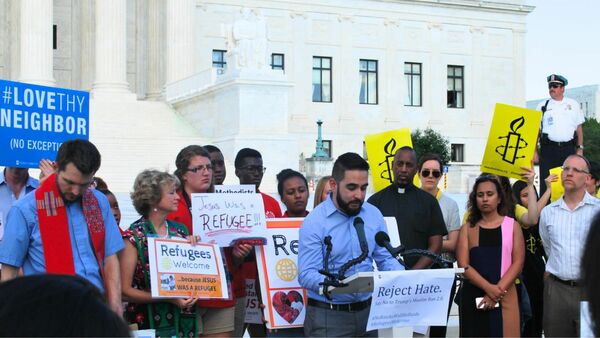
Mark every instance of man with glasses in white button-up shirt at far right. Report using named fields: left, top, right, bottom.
left=540, top=154, right=600, bottom=337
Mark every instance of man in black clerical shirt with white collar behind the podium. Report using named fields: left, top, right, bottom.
left=369, top=147, right=448, bottom=269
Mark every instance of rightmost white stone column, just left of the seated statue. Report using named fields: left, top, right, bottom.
left=166, top=0, right=196, bottom=85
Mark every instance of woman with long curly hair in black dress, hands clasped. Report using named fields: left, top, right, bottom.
left=456, top=175, right=525, bottom=337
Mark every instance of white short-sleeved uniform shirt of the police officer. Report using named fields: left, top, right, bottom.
left=537, top=97, right=585, bottom=142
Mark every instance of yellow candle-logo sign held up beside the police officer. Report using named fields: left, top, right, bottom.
left=481, top=103, right=542, bottom=180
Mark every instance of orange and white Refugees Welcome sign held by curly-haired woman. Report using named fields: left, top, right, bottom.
left=148, top=237, right=230, bottom=299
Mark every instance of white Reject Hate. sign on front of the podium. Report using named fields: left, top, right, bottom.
left=367, top=269, right=454, bottom=331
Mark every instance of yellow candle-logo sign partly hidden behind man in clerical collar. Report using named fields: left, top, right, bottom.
left=365, top=128, right=416, bottom=192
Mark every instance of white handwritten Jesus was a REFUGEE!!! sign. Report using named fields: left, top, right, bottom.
left=192, top=193, right=266, bottom=247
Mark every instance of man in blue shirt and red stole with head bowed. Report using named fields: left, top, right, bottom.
left=0, top=140, right=124, bottom=315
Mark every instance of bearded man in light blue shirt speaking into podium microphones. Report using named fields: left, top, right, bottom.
left=298, top=153, right=404, bottom=337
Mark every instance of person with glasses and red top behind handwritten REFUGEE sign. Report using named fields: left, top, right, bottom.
left=168, top=145, right=251, bottom=337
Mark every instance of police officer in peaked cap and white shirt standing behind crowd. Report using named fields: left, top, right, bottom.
left=537, top=74, right=585, bottom=194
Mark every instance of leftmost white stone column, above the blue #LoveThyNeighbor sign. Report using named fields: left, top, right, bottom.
left=19, top=0, right=55, bottom=86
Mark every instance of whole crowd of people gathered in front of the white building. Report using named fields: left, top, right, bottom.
left=0, top=75, right=600, bottom=337
